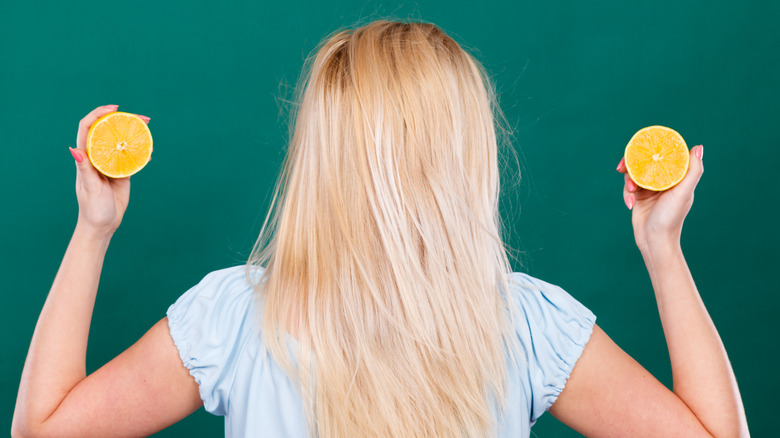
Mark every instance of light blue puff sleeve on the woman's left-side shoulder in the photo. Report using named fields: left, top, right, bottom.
left=167, top=266, right=255, bottom=416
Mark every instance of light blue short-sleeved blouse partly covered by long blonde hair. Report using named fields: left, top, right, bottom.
left=167, top=265, right=596, bottom=437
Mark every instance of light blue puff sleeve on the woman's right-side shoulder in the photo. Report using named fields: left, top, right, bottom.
left=510, top=273, right=596, bottom=425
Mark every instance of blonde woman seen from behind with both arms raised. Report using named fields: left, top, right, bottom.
left=13, top=21, right=748, bottom=437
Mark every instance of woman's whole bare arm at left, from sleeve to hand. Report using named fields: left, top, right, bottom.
left=12, top=107, right=200, bottom=437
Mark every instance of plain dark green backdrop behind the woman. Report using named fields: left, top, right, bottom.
left=0, top=0, right=780, bottom=437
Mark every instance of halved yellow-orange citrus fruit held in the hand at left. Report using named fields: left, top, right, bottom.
left=87, top=112, right=152, bottom=178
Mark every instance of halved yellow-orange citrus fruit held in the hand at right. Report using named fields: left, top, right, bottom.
left=625, top=126, right=690, bottom=192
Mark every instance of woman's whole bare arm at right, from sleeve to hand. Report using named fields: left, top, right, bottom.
left=550, top=146, right=749, bottom=437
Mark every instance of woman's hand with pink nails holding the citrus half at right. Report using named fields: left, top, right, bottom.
left=617, top=146, right=704, bottom=253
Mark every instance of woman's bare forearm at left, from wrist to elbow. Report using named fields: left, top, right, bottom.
left=14, top=225, right=110, bottom=432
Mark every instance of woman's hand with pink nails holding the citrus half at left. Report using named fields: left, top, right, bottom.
left=71, top=105, right=149, bottom=237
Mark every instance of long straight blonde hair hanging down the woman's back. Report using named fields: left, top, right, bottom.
left=247, top=20, right=514, bottom=437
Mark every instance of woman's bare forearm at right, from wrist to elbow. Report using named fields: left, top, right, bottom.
left=642, top=244, right=748, bottom=437
